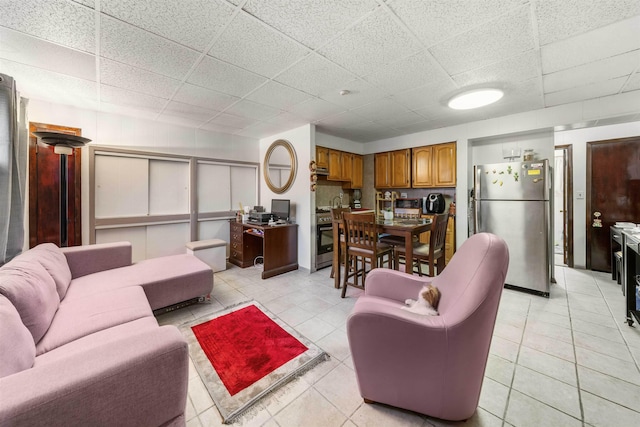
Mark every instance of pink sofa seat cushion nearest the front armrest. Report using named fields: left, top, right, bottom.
left=36, top=286, right=153, bottom=356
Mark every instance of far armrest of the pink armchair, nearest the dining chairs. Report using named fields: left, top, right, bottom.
left=364, top=268, right=433, bottom=303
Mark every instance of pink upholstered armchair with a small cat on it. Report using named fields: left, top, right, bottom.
left=347, top=233, right=509, bottom=421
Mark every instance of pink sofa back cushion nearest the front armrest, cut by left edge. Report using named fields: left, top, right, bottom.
left=0, top=296, right=36, bottom=378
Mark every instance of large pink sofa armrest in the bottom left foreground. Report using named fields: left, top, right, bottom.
left=0, top=326, right=189, bottom=426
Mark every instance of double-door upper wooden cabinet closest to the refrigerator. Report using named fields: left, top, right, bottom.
left=411, top=142, right=456, bottom=188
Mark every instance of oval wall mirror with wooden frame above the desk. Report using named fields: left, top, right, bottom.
left=263, top=139, right=297, bottom=194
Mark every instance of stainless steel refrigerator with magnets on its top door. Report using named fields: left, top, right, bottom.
left=473, top=160, right=554, bottom=297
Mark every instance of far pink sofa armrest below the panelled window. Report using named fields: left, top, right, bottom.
left=60, top=242, right=132, bottom=279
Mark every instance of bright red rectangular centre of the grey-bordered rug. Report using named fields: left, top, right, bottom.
left=191, top=305, right=308, bottom=396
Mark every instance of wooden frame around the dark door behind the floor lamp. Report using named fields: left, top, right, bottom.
left=29, top=122, right=82, bottom=248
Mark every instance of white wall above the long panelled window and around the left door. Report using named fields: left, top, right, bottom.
left=26, top=99, right=262, bottom=243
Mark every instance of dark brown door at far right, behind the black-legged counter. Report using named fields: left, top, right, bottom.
left=587, top=136, right=640, bottom=272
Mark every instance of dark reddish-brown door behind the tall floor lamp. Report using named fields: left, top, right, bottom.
left=29, top=122, right=82, bottom=247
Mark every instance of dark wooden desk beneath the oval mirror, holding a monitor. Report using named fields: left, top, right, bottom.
left=229, top=221, right=298, bottom=279
